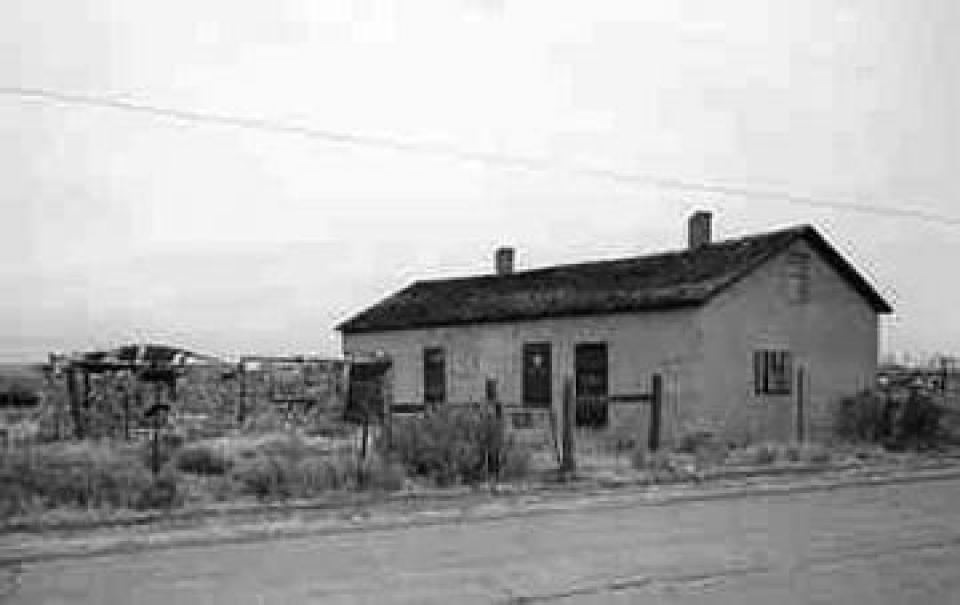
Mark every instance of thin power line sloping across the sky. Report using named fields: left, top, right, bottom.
left=0, top=86, right=960, bottom=226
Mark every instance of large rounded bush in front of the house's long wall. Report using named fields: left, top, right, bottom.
left=392, top=406, right=528, bottom=485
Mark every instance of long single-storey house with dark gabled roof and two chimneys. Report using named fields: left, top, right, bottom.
left=338, top=212, right=891, bottom=441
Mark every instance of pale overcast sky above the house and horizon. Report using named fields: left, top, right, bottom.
left=0, top=0, right=960, bottom=361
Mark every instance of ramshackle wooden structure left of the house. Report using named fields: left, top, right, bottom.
left=44, top=344, right=347, bottom=439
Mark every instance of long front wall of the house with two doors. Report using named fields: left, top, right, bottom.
left=343, top=310, right=701, bottom=439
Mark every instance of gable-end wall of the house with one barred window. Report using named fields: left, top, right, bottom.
left=687, top=241, right=877, bottom=440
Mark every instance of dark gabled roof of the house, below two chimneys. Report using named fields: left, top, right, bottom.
left=337, top=225, right=892, bottom=333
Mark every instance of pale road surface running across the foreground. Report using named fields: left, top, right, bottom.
left=0, top=477, right=960, bottom=605
